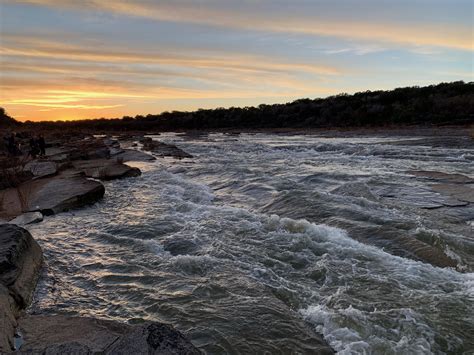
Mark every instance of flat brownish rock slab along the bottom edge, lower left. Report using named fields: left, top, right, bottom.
left=16, top=315, right=201, bottom=355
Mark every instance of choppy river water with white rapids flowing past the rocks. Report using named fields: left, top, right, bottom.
left=30, top=134, right=474, bottom=354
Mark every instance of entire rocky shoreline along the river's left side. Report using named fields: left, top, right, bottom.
left=0, top=136, right=200, bottom=354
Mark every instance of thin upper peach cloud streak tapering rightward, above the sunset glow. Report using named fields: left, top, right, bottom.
left=0, top=33, right=343, bottom=75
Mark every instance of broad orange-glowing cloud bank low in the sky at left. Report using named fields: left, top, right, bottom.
left=0, top=33, right=344, bottom=117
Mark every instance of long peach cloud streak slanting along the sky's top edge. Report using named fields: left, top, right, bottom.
left=12, top=0, right=473, bottom=51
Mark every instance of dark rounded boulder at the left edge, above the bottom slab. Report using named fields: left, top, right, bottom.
left=0, top=224, right=43, bottom=308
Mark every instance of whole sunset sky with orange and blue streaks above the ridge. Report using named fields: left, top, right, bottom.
left=0, top=0, right=474, bottom=121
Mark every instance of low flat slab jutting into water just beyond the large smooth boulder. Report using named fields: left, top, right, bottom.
left=72, top=159, right=141, bottom=180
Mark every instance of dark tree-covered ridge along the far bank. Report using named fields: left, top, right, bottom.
left=1, top=81, right=474, bottom=131
